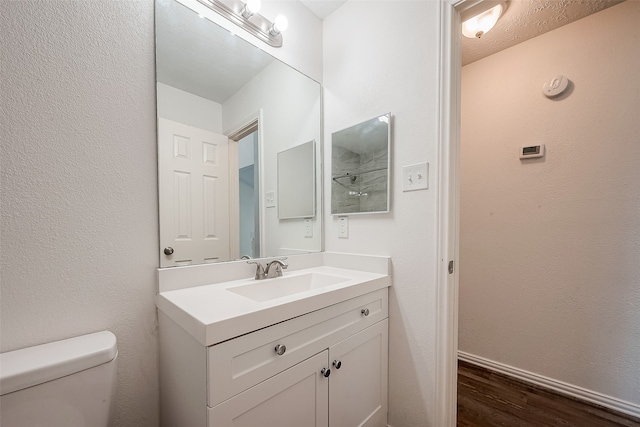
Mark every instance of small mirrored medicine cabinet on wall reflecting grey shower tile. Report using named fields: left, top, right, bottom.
left=331, top=113, right=391, bottom=215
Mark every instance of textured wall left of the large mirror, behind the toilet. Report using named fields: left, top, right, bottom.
left=0, top=0, right=158, bottom=427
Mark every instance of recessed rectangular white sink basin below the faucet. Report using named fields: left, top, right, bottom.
left=227, top=273, right=350, bottom=302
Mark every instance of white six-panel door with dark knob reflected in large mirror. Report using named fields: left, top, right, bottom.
left=158, top=118, right=229, bottom=267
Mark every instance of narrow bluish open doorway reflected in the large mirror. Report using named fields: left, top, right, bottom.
left=238, top=131, right=260, bottom=258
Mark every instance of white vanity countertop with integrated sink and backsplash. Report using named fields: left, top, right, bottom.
left=157, top=260, right=391, bottom=346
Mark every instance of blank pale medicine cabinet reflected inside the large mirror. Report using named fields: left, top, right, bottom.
left=278, top=141, right=316, bottom=219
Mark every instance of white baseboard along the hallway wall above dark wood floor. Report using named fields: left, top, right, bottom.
left=458, top=351, right=640, bottom=418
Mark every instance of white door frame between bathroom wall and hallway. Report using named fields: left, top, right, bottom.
left=434, top=0, right=490, bottom=427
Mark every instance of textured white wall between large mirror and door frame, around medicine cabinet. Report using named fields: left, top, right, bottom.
left=323, top=1, right=439, bottom=427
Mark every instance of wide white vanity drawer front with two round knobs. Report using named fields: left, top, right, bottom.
left=207, top=288, right=388, bottom=407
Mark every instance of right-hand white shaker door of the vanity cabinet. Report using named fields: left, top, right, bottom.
left=329, top=319, right=389, bottom=427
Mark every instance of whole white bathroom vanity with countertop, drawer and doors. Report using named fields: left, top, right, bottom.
left=158, top=253, right=391, bottom=427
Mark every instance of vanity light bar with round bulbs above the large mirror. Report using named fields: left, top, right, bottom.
left=198, top=0, right=289, bottom=47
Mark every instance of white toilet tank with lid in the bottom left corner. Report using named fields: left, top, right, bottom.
left=0, top=331, right=118, bottom=427
